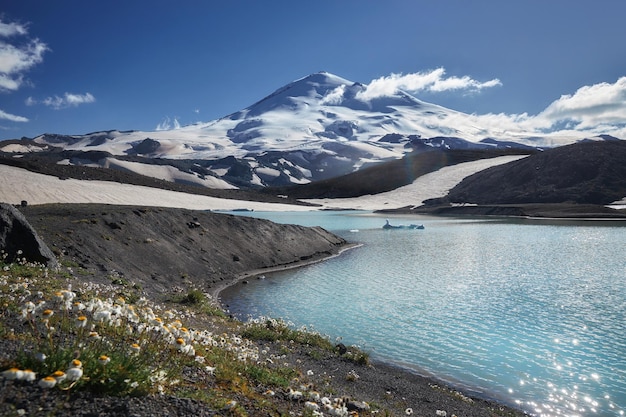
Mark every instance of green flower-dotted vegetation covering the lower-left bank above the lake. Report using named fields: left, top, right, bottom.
left=0, top=260, right=372, bottom=415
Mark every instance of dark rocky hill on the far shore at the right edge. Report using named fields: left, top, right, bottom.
left=427, top=140, right=626, bottom=206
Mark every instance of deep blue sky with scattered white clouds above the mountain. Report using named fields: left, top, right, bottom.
left=0, top=0, right=626, bottom=139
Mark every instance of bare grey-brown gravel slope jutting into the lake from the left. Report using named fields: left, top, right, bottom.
left=20, top=204, right=346, bottom=296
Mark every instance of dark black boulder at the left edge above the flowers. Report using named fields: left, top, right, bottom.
left=0, top=203, right=58, bottom=268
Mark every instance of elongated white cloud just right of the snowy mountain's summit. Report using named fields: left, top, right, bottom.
left=357, top=68, right=502, bottom=100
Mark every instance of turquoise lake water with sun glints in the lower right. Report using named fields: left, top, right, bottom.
left=222, top=212, right=626, bottom=416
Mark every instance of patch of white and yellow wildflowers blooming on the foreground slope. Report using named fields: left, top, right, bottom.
left=0, top=261, right=380, bottom=416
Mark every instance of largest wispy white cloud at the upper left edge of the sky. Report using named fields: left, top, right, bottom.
left=0, top=21, right=48, bottom=92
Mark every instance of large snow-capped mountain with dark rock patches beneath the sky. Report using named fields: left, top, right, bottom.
left=25, top=72, right=572, bottom=188
